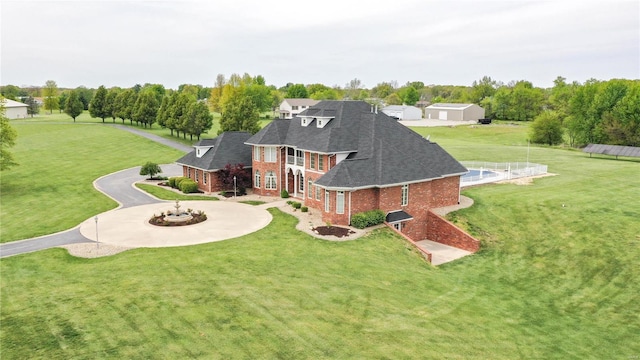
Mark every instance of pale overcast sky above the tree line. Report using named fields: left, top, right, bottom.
left=0, top=0, right=640, bottom=88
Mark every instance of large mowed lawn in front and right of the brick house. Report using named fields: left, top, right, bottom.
left=0, top=120, right=640, bottom=359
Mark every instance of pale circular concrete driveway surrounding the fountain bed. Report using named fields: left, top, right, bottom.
left=80, top=201, right=272, bottom=247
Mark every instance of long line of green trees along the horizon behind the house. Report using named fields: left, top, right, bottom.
left=0, top=73, right=640, bottom=146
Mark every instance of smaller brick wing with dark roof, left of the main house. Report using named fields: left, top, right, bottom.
left=176, top=131, right=251, bottom=193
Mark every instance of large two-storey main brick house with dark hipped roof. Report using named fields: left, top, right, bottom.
left=245, top=101, right=467, bottom=240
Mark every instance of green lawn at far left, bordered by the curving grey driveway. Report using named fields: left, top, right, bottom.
left=0, top=120, right=183, bottom=242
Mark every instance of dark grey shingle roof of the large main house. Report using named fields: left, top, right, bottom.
left=246, top=101, right=467, bottom=189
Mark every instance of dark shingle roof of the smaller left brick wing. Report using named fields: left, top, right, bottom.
left=176, top=131, right=251, bottom=171
